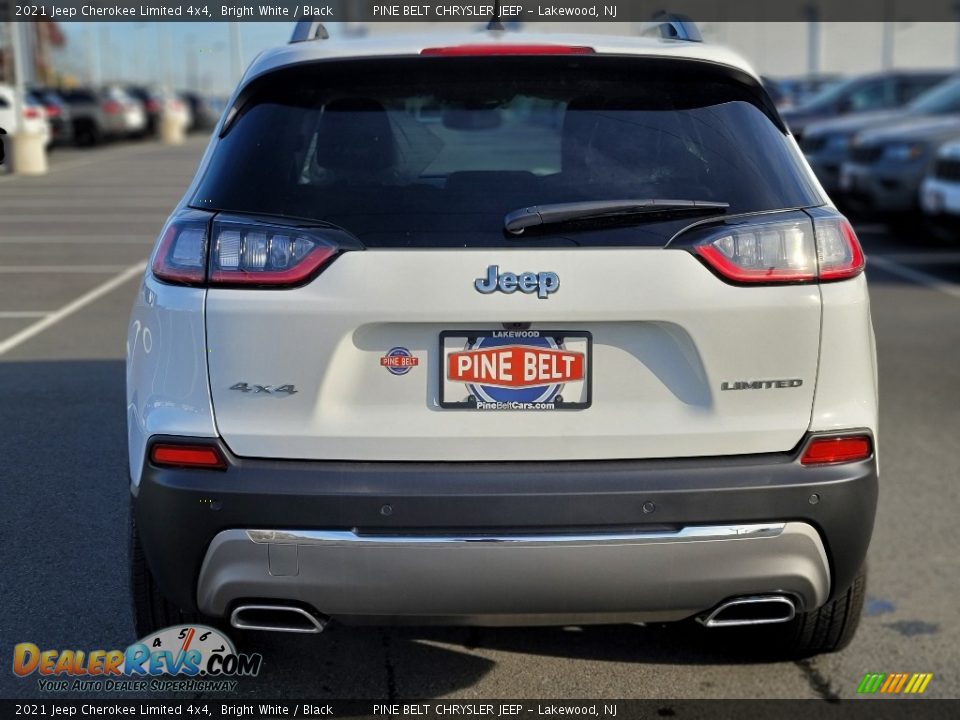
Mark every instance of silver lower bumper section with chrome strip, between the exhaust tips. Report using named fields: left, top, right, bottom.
left=198, top=523, right=830, bottom=625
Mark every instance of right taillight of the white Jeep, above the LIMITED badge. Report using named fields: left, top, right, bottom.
left=693, top=216, right=865, bottom=284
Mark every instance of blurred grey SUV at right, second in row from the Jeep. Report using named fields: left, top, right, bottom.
left=800, top=76, right=960, bottom=194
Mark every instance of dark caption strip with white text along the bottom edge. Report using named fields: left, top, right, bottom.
left=0, top=698, right=960, bottom=720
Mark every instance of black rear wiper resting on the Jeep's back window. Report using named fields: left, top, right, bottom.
left=503, top=198, right=730, bottom=235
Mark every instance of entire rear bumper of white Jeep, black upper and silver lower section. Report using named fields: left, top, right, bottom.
left=133, top=438, right=877, bottom=623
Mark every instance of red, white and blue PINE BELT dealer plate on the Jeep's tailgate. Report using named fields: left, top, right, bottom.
left=439, top=330, right=593, bottom=411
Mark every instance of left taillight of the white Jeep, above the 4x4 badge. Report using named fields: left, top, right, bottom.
left=152, top=219, right=340, bottom=287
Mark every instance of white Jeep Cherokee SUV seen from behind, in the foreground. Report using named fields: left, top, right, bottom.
left=127, top=23, right=877, bottom=654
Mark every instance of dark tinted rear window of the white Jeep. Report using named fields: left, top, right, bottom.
left=192, top=57, right=823, bottom=247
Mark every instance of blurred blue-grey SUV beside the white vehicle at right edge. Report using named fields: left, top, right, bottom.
left=839, top=115, right=960, bottom=224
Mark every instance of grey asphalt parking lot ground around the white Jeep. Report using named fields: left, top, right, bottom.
left=0, top=137, right=960, bottom=699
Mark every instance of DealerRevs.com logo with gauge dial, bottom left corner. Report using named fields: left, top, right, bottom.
left=13, top=625, right=263, bottom=692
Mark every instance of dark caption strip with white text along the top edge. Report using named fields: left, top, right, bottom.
left=0, top=0, right=960, bottom=22
